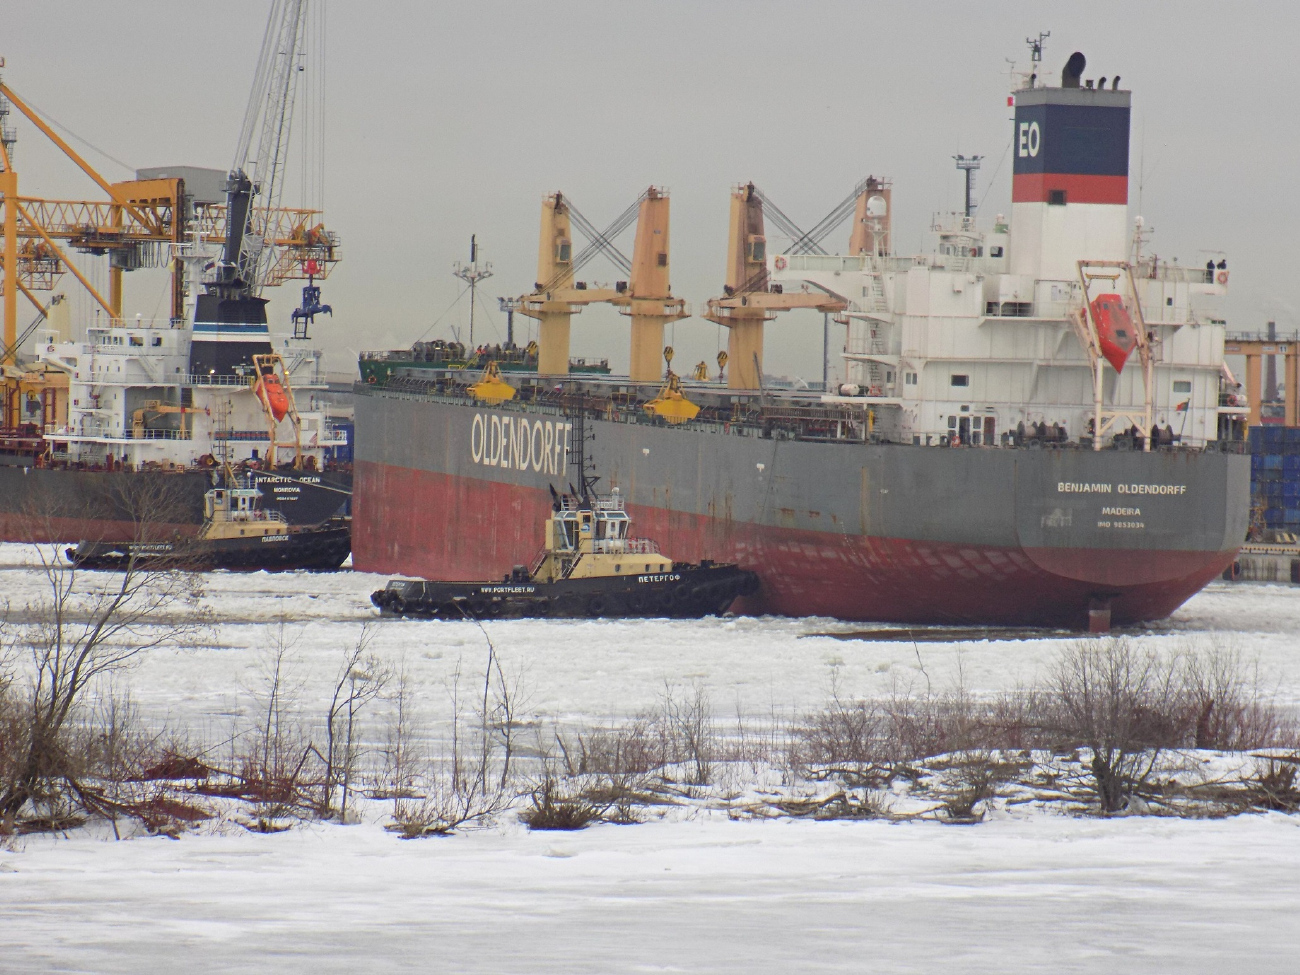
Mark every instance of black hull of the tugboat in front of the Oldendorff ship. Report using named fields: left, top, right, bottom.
left=371, top=564, right=758, bottom=620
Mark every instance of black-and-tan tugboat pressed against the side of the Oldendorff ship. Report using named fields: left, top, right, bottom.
left=371, top=387, right=758, bottom=620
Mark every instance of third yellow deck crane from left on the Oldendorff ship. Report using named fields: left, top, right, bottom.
left=703, top=183, right=849, bottom=390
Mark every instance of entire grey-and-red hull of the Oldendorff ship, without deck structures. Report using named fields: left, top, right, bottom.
left=354, top=386, right=1249, bottom=627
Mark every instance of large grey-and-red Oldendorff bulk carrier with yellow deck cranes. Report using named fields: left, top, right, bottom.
left=354, top=55, right=1251, bottom=629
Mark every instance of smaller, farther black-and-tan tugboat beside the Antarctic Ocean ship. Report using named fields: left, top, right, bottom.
left=68, top=480, right=352, bottom=572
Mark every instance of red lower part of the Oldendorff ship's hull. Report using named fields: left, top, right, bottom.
left=354, top=463, right=1235, bottom=628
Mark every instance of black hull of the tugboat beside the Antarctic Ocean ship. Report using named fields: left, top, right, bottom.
left=68, top=521, right=352, bottom=572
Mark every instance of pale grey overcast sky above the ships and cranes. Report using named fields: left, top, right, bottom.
left=10, top=0, right=1300, bottom=378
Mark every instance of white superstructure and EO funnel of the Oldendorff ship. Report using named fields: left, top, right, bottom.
left=768, top=55, right=1247, bottom=445
